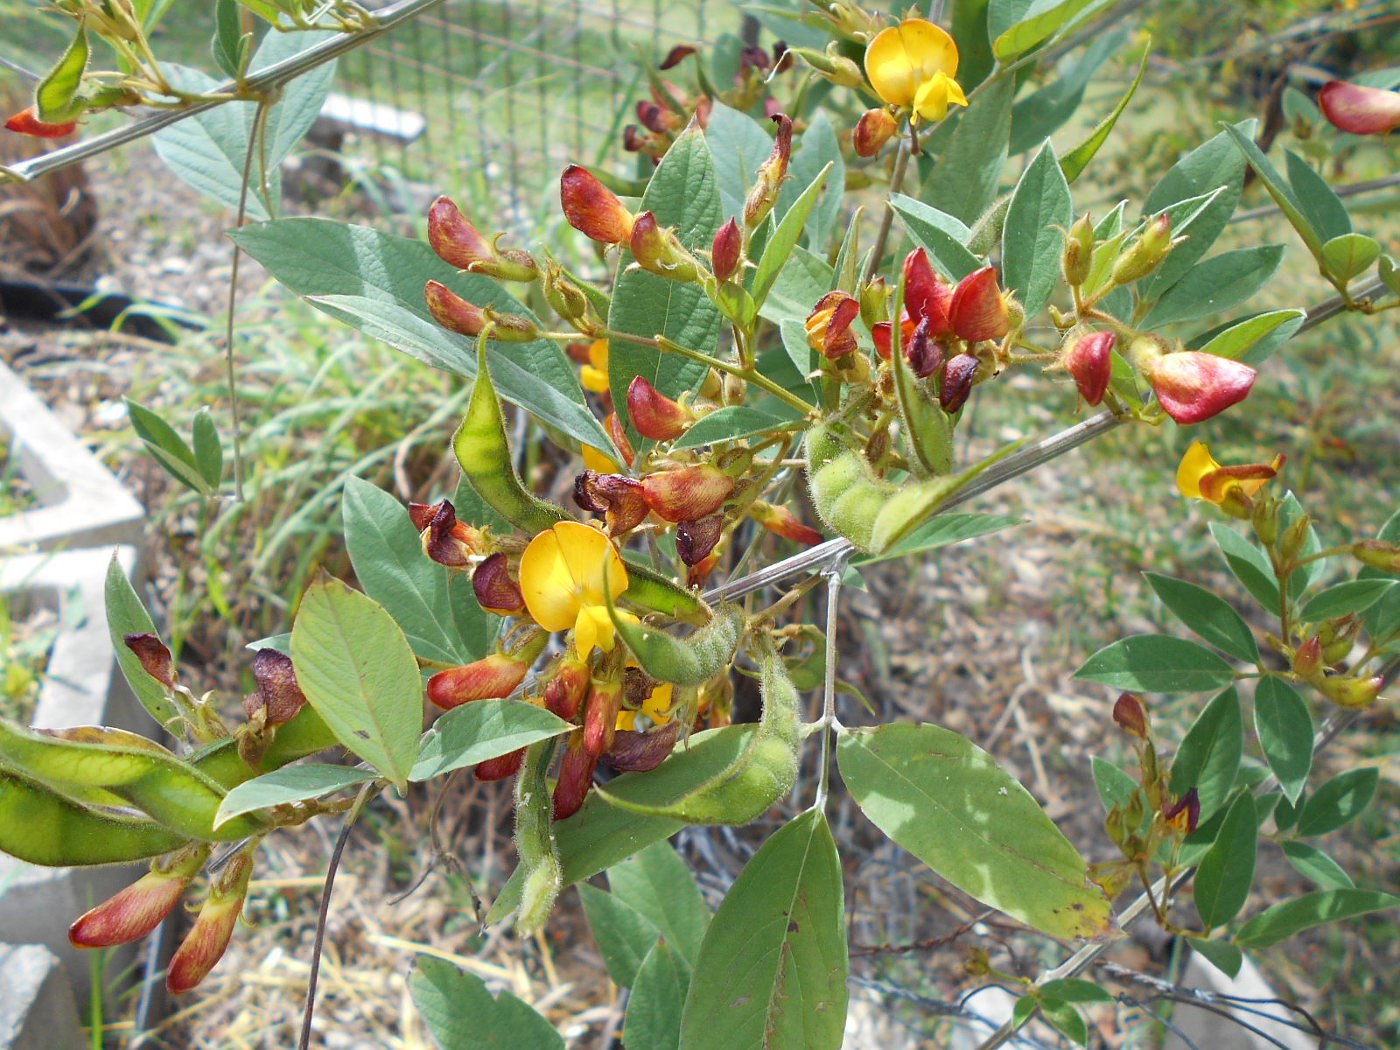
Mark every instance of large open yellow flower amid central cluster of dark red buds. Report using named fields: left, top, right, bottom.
left=521, top=521, right=636, bottom=657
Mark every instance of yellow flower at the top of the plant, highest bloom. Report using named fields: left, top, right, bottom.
left=865, top=18, right=967, bottom=120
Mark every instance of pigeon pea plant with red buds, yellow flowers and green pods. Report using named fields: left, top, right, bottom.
left=0, top=0, right=1400, bottom=1050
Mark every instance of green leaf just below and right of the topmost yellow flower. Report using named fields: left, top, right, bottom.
left=918, top=76, right=1016, bottom=223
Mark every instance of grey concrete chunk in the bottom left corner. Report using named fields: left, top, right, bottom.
left=0, top=944, right=85, bottom=1050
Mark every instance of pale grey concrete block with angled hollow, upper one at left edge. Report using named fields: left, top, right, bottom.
left=0, top=364, right=146, bottom=552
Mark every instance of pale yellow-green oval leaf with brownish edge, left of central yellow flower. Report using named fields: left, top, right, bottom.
left=291, top=578, right=423, bottom=790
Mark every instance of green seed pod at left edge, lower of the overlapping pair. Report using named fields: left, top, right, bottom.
left=0, top=773, right=188, bottom=868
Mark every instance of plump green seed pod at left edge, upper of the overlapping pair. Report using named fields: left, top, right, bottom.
left=0, top=722, right=267, bottom=841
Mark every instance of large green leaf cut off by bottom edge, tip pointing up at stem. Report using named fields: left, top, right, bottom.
left=680, top=809, right=848, bottom=1050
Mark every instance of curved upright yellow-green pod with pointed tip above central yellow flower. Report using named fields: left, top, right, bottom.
left=452, top=339, right=568, bottom=533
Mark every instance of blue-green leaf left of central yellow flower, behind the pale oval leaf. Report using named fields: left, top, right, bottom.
left=340, top=477, right=494, bottom=665
